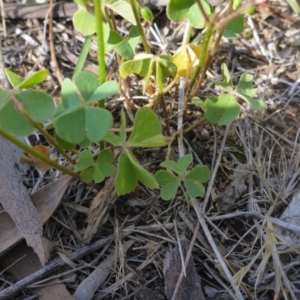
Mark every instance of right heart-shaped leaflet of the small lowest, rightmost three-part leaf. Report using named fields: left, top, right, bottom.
left=183, top=166, right=210, bottom=198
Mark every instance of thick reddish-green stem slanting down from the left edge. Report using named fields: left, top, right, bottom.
left=0, top=128, right=82, bottom=181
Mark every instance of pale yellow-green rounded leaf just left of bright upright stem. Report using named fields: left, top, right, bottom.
left=73, top=9, right=96, bottom=35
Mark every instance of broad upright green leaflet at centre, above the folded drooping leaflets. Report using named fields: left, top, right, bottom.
left=128, top=108, right=168, bottom=148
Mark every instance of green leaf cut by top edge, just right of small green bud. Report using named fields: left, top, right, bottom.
left=167, top=0, right=194, bottom=22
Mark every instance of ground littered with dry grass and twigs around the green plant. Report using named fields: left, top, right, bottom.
left=0, top=1, right=300, bottom=300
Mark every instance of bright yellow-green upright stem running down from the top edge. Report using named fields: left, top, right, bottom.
left=94, top=0, right=106, bottom=83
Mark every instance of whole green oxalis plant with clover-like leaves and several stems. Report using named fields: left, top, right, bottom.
left=0, top=0, right=265, bottom=200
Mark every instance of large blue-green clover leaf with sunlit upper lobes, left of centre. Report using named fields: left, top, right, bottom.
left=54, top=72, right=118, bottom=144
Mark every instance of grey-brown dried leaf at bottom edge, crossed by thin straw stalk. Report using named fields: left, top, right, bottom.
left=164, top=236, right=205, bottom=300
